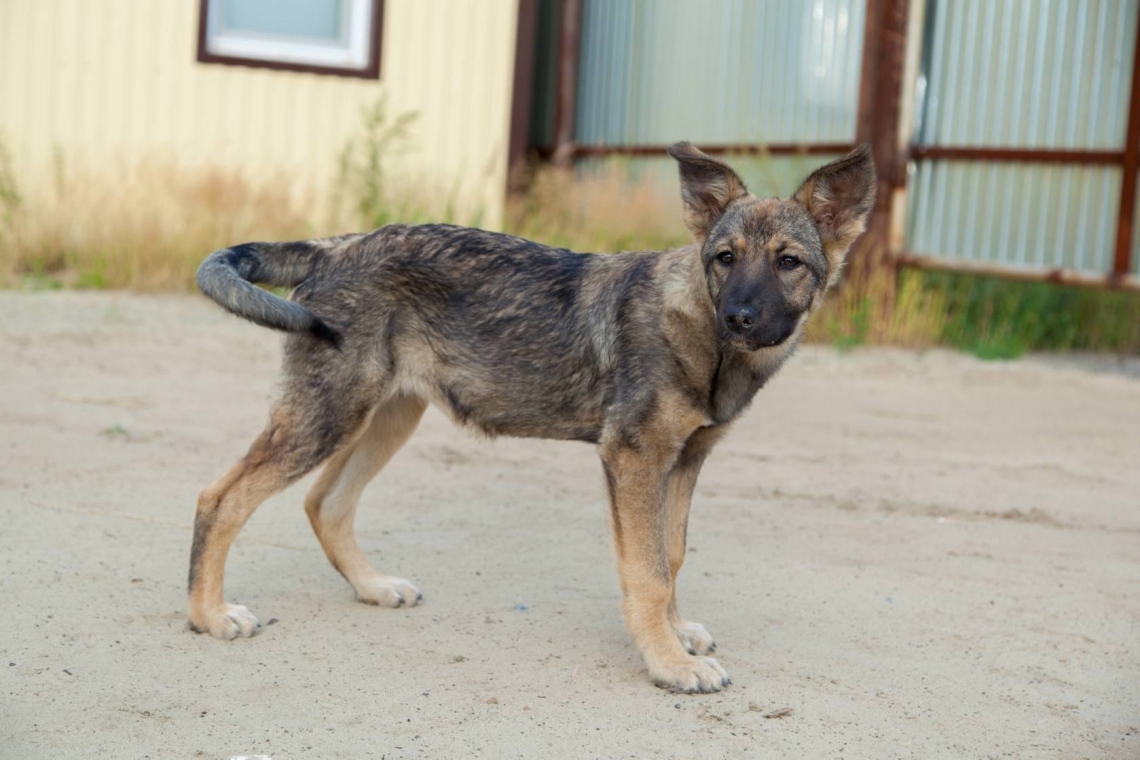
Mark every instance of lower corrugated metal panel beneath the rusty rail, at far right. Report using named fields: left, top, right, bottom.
left=906, top=161, right=1121, bottom=275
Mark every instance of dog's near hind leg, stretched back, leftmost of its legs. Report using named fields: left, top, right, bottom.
left=189, top=391, right=372, bottom=639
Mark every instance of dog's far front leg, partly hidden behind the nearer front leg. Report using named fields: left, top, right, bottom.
left=665, top=426, right=724, bottom=655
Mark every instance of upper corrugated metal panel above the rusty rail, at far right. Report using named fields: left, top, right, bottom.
left=918, top=0, right=1140, bottom=150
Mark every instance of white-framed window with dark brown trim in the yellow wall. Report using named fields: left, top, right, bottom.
left=198, top=0, right=384, bottom=79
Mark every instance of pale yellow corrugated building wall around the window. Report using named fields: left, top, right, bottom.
left=0, top=0, right=518, bottom=227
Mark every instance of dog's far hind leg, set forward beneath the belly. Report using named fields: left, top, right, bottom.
left=304, top=395, right=426, bottom=607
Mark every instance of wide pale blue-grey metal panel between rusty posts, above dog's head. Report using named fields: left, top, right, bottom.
left=576, top=0, right=865, bottom=146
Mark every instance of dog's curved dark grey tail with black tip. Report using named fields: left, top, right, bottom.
left=198, top=240, right=340, bottom=345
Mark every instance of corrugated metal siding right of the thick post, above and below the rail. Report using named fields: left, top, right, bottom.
left=906, top=0, right=1140, bottom=275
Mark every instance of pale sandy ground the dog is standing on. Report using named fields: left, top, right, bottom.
left=0, top=293, right=1140, bottom=760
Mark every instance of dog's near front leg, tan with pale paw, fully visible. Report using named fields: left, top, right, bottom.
left=602, top=444, right=730, bottom=693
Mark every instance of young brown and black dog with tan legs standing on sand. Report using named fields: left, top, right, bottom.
left=188, top=142, right=877, bottom=693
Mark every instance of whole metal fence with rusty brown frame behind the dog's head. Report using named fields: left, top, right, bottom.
left=530, top=0, right=1140, bottom=287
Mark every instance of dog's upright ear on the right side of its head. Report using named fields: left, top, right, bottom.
left=792, top=142, right=879, bottom=272
